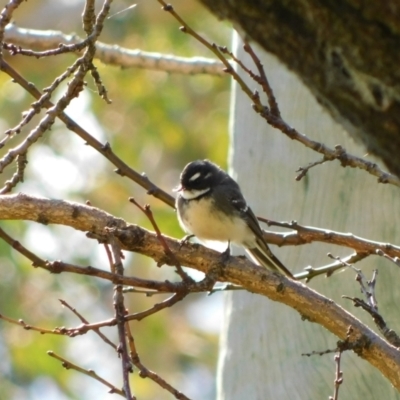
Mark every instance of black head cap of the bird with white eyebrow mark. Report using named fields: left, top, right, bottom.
left=180, top=160, right=226, bottom=191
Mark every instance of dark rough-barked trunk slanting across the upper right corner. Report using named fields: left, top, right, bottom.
left=201, top=0, right=400, bottom=176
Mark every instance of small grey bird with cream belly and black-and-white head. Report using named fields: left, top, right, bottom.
left=175, top=160, right=293, bottom=278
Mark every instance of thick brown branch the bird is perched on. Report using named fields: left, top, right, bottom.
left=0, top=195, right=400, bottom=390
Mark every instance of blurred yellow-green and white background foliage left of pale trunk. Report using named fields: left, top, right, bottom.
left=0, top=0, right=230, bottom=400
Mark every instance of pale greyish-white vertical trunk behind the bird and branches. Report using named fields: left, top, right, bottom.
left=218, top=32, right=400, bottom=400
